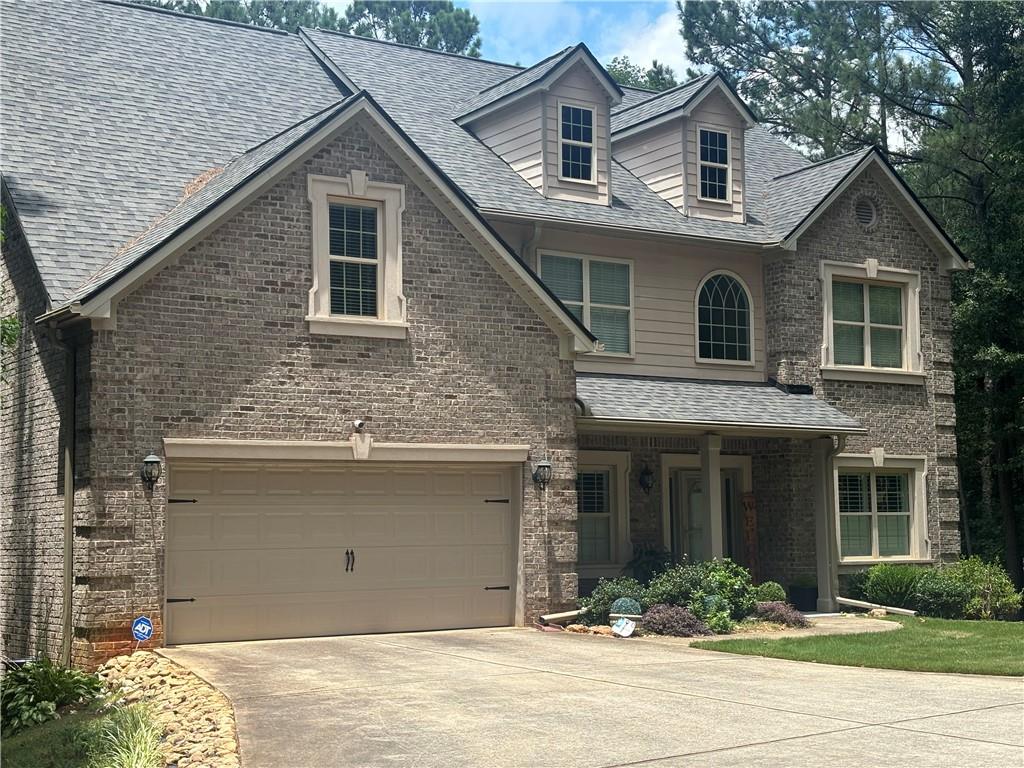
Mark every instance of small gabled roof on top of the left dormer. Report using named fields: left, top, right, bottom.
left=455, top=43, right=624, bottom=125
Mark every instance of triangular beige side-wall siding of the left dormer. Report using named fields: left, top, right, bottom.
left=472, top=95, right=544, bottom=193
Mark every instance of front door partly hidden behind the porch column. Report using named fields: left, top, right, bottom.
left=669, top=469, right=743, bottom=562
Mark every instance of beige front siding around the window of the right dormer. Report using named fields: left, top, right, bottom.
left=684, top=92, right=743, bottom=221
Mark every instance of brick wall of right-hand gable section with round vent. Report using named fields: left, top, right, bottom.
left=765, top=170, right=959, bottom=559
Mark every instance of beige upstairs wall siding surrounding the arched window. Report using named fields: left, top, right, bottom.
left=496, top=222, right=765, bottom=381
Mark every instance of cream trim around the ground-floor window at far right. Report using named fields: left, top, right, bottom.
left=833, top=449, right=932, bottom=565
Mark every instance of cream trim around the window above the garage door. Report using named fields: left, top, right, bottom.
left=306, top=170, right=409, bottom=339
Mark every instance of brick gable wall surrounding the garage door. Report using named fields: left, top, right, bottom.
left=68, top=126, right=577, bottom=665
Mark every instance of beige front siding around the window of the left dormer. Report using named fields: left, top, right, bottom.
left=544, top=65, right=611, bottom=205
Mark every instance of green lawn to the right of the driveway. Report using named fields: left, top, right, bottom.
left=691, top=616, right=1024, bottom=676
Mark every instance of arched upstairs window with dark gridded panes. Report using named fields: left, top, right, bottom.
left=697, top=272, right=751, bottom=362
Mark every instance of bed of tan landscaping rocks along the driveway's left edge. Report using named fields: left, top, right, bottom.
left=98, top=651, right=240, bottom=768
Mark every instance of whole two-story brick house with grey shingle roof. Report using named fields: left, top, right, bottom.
left=0, top=2, right=965, bottom=665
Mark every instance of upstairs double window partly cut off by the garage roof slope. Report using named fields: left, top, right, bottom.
left=541, top=253, right=633, bottom=355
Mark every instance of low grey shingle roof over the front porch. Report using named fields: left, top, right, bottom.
left=577, top=374, right=863, bottom=433
